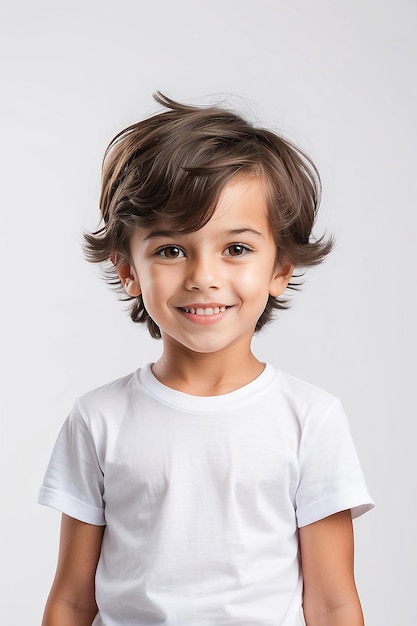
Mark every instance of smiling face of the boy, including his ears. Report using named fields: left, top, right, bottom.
left=119, top=177, right=293, bottom=353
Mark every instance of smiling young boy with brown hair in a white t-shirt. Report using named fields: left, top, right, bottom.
left=39, top=94, right=373, bottom=626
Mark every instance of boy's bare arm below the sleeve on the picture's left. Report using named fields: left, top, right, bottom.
left=42, top=515, right=104, bottom=626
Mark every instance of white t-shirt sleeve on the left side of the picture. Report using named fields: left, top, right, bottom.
left=38, top=406, right=106, bottom=526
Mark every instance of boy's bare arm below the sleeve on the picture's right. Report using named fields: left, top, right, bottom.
left=299, top=511, right=364, bottom=626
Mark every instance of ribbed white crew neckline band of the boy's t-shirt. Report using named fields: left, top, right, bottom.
left=137, top=363, right=277, bottom=413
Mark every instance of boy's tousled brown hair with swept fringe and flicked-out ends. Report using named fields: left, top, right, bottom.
left=84, top=92, right=332, bottom=338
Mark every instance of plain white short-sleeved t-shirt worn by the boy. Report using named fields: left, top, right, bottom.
left=39, top=365, right=373, bottom=626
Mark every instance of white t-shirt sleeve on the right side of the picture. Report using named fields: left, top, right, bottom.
left=296, top=399, right=374, bottom=527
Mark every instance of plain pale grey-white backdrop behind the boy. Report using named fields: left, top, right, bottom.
left=0, top=0, right=417, bottom=626
